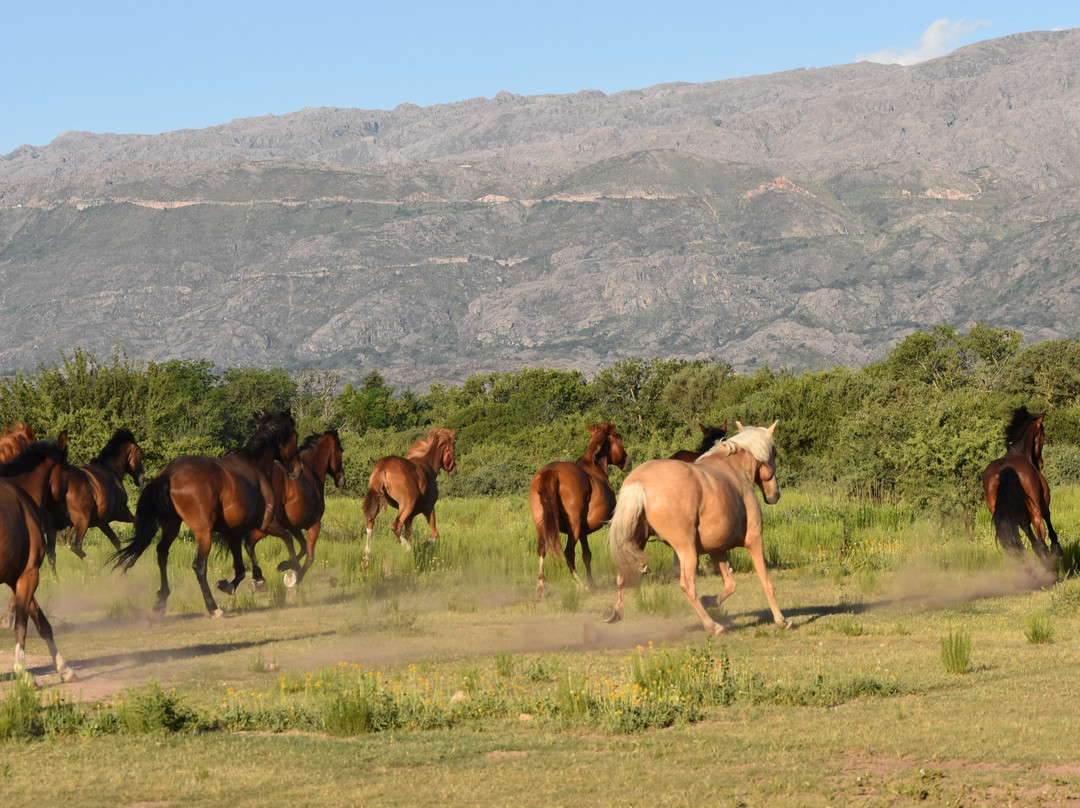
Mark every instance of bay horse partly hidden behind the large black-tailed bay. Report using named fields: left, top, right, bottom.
left=247, top=429, right=345, bottom=589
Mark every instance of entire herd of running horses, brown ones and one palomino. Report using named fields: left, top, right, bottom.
left=0, top=407, right=1062, bottom=682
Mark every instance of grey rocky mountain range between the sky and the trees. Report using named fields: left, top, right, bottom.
left=0, top=29, right=1080, bottom=390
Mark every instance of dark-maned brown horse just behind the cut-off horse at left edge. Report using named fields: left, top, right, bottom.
left=57, top=429, right=146, bottom=569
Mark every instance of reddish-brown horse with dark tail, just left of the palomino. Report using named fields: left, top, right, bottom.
left=529, top=423, right=630, bottom=597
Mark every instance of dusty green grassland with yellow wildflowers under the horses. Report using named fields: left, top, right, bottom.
left=0, top=489, right=1080, bottom=806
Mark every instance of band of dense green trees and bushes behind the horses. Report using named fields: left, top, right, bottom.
left=0, top=324, right=1080, bottom=527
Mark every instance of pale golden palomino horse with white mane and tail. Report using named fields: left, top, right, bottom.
left=604, top=421, right=788, bottom=634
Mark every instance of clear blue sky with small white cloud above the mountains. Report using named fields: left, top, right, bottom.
left=0, top=0, right=1080, bottom=154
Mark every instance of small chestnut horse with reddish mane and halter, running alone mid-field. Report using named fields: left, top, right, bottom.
left=364, top=427, right=458, bottom=566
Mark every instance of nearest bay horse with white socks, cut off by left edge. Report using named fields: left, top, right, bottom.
left=0, top=432, right=78, bottom=682
